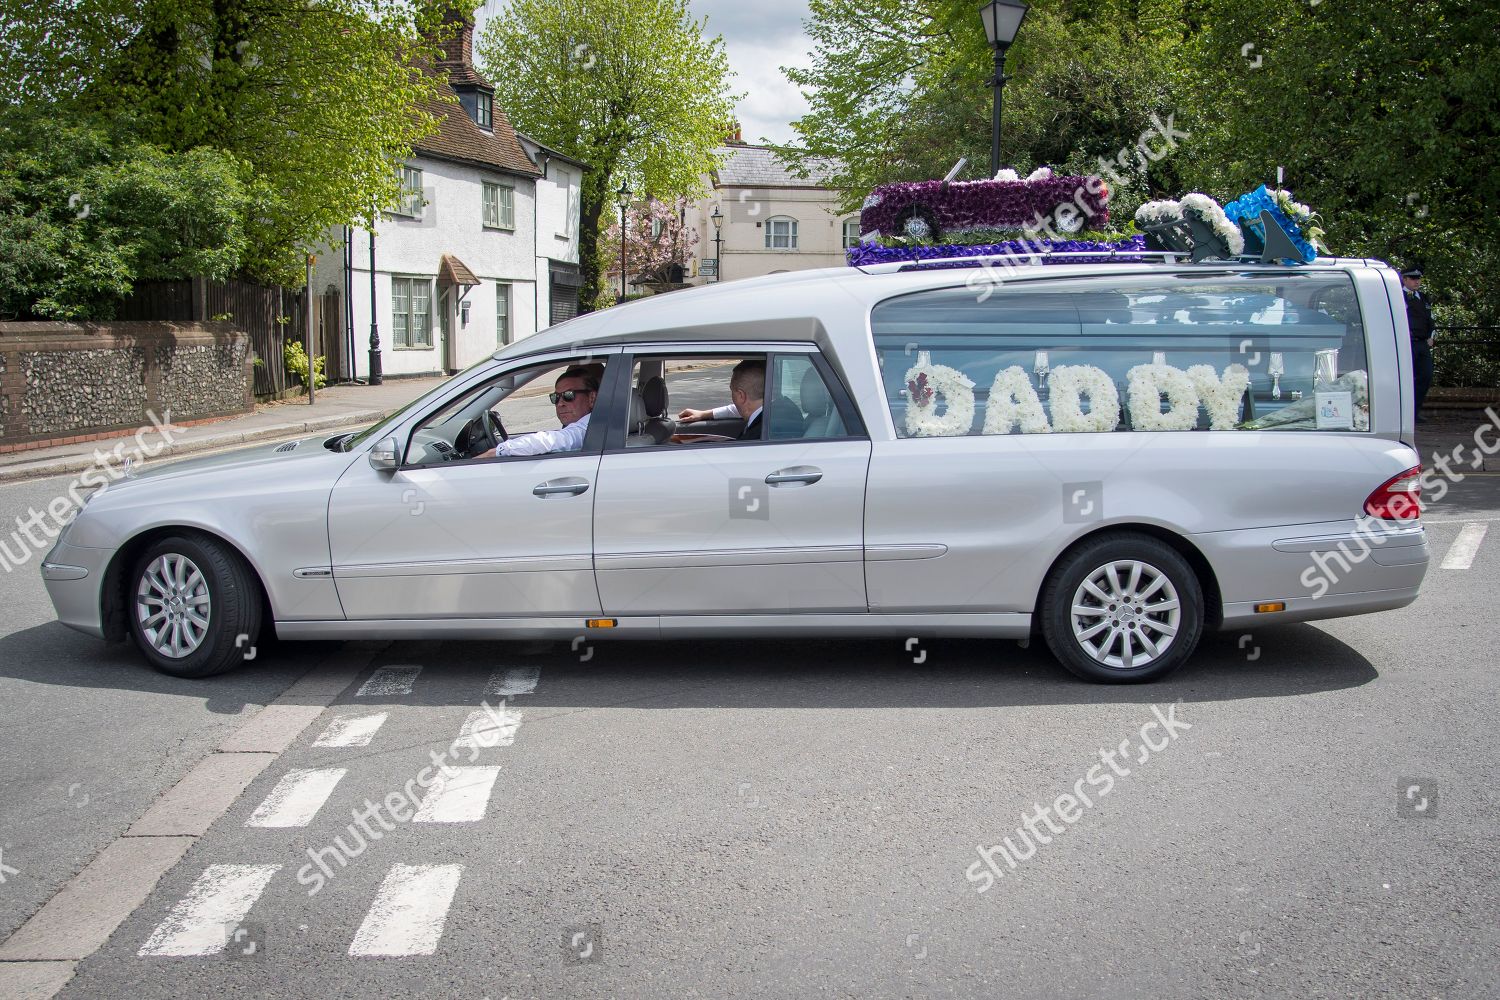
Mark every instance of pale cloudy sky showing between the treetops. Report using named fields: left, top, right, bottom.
left=477, top=0, right=813, bottom=142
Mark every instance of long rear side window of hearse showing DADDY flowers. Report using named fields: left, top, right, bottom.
left=872, top=273, right=1370, bottom=438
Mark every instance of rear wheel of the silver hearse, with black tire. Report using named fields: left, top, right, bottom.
left=1041, top=531, right=1203, bottom=684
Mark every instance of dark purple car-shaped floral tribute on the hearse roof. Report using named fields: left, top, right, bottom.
left=860, top=166, right=1110, bottom=243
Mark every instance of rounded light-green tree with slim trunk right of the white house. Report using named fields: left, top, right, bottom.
left=479, top=0, right=737, bottom=306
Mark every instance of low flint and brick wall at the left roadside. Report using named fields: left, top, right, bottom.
left=0, top=322, right=255, bottom=451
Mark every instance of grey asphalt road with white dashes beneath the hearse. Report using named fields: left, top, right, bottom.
left=0, top=458, right=1500, bottom=1000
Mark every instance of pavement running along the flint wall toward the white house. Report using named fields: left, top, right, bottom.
left=0, top=376, right=447, bottom=483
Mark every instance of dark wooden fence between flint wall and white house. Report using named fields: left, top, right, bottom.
left=120, top=279, right=344, bottom=399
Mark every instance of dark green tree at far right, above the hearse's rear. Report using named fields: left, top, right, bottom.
left=1181, top=0, right=1500, bottom=324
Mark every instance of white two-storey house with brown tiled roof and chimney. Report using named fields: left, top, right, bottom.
left=312, top=11, right=585, bottom=379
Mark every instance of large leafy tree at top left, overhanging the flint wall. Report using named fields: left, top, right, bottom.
left=0, top=0, right=456, bottom=308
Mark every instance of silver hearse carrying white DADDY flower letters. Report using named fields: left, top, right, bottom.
left=42, top=255, right=1428, bottom=682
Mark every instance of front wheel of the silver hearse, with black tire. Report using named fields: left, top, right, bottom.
left=125, top=534, right=261, bottom=678
